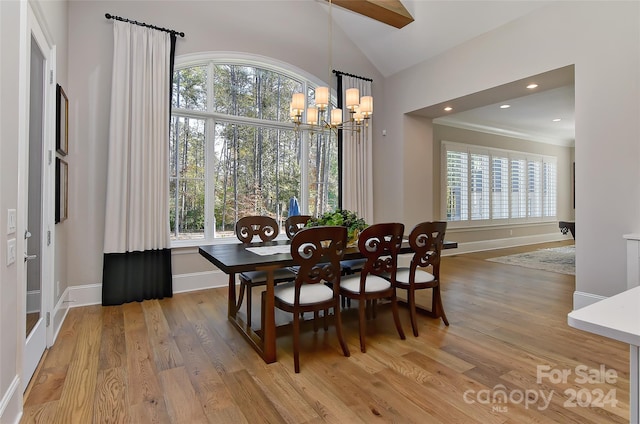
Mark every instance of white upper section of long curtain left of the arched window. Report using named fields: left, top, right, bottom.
left=104, top=21, right=171, bottom=253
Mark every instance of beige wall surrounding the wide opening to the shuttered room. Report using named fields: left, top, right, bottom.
left=374, top=1, right=640, bottom=304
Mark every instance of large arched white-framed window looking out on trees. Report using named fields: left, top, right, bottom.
left=169, top=53, right=339, bottom=246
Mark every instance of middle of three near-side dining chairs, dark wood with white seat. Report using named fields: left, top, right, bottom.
left=340, top=223, right=405, bottom=352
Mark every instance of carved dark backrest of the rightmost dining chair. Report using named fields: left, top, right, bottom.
left=409, top=221, right=447, bottom=279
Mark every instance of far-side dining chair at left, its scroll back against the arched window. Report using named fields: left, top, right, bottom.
left=235, top=215, right=296, bottom=326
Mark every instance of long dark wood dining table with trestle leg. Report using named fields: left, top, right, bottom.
left=199, top=240, right=458, bottom=364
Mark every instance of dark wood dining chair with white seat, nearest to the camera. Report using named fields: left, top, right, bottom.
left=274, top=226, right=350, bottom=373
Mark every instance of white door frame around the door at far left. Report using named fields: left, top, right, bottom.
left=16, top=1, right=56, bottom=392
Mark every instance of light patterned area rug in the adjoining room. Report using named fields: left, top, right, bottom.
left=487, top=245, right=576, bottom=275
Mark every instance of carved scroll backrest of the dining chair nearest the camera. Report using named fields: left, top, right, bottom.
left=291, top=226, right=347, bottom=294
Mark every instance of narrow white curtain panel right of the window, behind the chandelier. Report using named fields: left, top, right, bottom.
left=342, top=75, right=373, bottom=223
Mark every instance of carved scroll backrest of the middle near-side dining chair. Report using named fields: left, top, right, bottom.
left=358, top=222, right=404, bottom=282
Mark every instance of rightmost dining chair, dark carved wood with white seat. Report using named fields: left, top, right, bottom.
left=395, top=221, right=449, bottom=337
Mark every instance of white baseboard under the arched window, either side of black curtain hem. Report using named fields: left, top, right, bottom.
left=66, top=270, right=229, bottom=308
